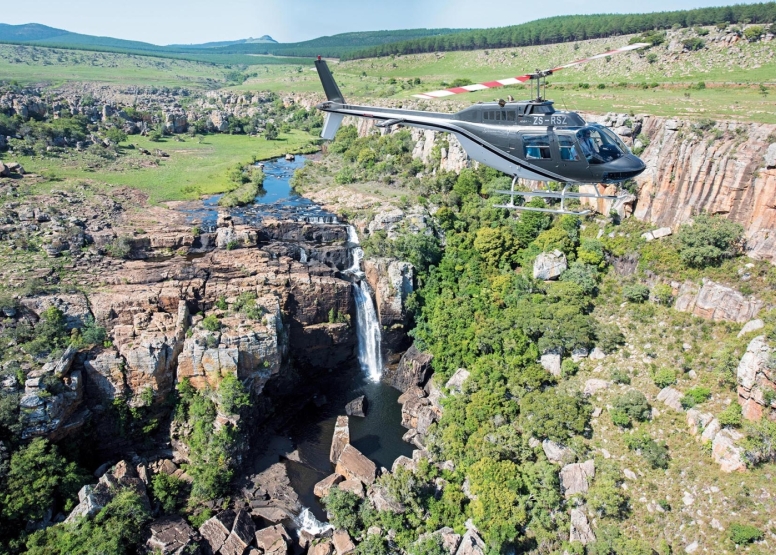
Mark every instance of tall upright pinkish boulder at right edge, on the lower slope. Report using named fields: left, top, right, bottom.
left=736, top=335, right=776, bottom=420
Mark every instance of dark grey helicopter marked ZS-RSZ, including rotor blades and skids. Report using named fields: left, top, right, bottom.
left=315, top=43, right=650, bottom=215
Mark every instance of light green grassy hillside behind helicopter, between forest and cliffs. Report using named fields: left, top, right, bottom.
left=237, top=28, right=776, bottom=122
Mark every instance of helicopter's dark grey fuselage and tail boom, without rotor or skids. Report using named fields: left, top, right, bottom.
left=318, top=101, right=646, bottom=183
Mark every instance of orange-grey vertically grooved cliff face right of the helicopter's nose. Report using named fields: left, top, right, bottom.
left=634, top=117, right=776, bottom=262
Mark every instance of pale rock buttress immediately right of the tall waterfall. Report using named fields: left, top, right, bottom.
left=364, top=258, right=415, bottom=352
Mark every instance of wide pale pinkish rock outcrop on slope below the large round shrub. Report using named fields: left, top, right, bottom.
left=674, top=279, right=763, bottom=324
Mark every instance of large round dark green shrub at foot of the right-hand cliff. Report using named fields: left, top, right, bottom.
left=678, top=214, right=744, bottom=268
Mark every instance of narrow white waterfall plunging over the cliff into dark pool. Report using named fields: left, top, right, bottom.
left=346, top=225, right=383, bottom=382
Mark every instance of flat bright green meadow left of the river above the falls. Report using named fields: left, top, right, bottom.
left=10, top=131, right=314, bottom=203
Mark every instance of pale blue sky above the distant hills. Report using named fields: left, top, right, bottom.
left=0, top=0, right=764, bottom=44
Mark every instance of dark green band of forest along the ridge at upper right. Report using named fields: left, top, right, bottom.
left=343, top=2, right=776, bottom=60
